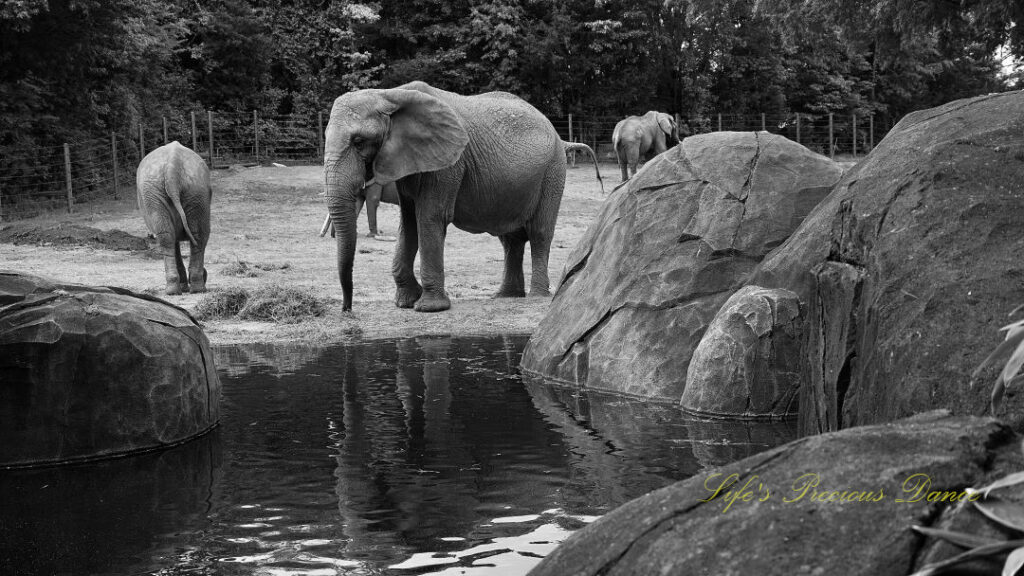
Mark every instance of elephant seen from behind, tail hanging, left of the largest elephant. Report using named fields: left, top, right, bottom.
left=136, top=141, right=213, bottom=294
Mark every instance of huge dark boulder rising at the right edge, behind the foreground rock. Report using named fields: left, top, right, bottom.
left=751, top=91, right=1024, bottom=433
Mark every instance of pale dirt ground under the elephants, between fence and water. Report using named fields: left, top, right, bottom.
left=0, top=158, right=618, bottom=343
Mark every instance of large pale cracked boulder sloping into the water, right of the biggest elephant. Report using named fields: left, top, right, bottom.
left=522, top=132, right=842, bottom=401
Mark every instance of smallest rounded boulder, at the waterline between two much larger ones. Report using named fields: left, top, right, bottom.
left=680, top=286, right=800, bottom=418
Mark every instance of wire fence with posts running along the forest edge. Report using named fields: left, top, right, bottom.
left=0, top=111, right=892, bottom=221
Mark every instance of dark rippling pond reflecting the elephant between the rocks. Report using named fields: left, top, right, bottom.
left=0, top=336, right=796, bottom=575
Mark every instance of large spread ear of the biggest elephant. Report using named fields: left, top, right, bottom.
left=374, top=88, right=469, bottom=184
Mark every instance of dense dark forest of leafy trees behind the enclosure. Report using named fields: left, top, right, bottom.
left=0, top=0, right=1024, bottom=153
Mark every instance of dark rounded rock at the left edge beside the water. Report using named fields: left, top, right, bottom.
left=0, top=272, right=220, bottom=466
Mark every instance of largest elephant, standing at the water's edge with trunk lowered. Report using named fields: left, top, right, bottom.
left=324, top=82, right=597, bottom=312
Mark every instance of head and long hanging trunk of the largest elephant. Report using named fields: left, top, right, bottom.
left=324, top=88, right=469, bottom=311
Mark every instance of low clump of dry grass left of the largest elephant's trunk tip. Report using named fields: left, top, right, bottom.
left=196, top=285, right=328, bottom=324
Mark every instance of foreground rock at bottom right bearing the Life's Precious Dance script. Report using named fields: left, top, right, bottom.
left=529, top=412, right=1021, bottom=576
